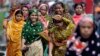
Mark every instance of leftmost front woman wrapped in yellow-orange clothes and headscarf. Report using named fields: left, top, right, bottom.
left=6, top=10, right=24, bottom=56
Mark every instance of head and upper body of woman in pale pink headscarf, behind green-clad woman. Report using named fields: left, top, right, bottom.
left=39, top=4, right=50, bottom=29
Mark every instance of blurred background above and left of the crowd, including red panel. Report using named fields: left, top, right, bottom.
left=0, top=0, right=99, bottom=56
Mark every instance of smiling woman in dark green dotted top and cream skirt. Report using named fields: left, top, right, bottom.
left=22, top=9, right=43, bottom=56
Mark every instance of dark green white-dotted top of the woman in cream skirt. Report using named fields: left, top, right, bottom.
left=22, top=20, right=43, bottom=44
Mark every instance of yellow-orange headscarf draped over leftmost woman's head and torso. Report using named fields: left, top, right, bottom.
left=7, top=9, right=24, bottom=42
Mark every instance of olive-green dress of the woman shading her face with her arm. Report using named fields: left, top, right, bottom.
left=49, top=18, right=74, bottom=56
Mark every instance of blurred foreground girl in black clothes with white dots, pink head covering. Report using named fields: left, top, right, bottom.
left=65, top=16, right=100, bottom=56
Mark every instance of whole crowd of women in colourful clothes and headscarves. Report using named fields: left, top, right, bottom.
left=3, top=2, right=100, bottom=56
